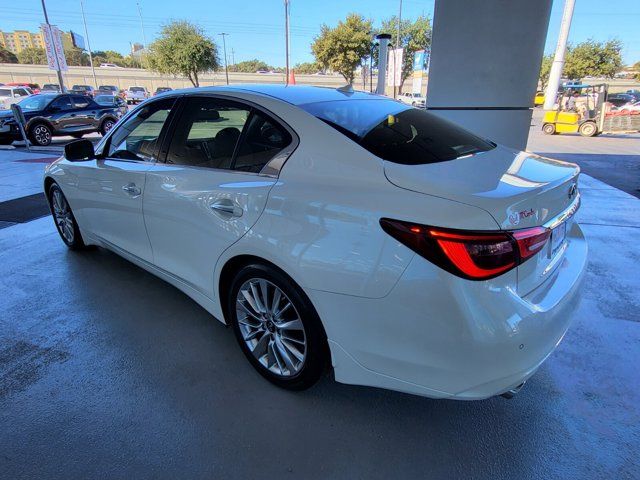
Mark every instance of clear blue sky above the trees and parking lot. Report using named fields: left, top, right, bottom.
left=0, top=0, right=640, bottom=66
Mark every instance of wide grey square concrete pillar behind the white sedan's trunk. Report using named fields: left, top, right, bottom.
left=427, top=0, right=551, bottom=149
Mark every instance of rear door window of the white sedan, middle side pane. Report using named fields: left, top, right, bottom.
left=167, top=97, right=251, bottom=169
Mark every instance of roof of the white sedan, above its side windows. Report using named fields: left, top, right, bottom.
left=165, top=84, right=384, bottom=105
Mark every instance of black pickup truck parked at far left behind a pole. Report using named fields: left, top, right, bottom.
left=0, top=94, right=123, bottom=146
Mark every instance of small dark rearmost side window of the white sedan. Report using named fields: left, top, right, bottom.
left=232, top=111, right=291, bottom=173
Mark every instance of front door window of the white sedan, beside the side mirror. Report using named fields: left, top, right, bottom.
left=107, top=98, right=175, bottom=162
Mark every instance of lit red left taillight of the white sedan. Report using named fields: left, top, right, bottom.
left=380, top=218, right=551, bottom=280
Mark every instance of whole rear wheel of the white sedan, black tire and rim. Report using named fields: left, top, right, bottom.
left=227, top=264, right=329, bottom=390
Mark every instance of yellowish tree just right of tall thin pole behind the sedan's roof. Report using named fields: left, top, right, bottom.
left=311, top=13, right=371, bottom=83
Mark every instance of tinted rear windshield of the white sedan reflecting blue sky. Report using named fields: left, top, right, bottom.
left=300, top=99, right=495, bottom=165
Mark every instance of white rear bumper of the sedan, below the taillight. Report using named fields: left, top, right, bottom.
left=310, top=224, right=587, bottom=400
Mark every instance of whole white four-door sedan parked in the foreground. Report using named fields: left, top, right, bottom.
left=44, top=85, right=587, bottom=399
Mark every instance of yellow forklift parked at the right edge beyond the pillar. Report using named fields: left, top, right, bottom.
left=542, top=83, right=640, bottom=137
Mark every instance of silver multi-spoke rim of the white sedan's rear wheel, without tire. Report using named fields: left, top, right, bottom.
left=236, top=278, right=307, bottom=377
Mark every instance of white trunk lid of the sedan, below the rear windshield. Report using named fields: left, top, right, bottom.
left=384, top=146, right=580, bottom=230
